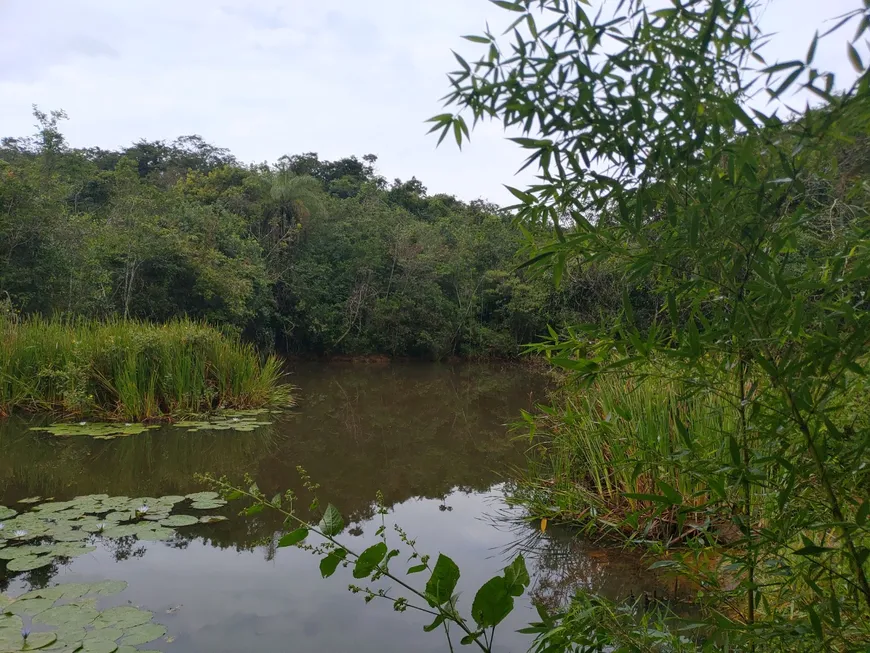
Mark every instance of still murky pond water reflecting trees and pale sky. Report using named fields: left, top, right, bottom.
left=0, top=363, right=655, bottom=653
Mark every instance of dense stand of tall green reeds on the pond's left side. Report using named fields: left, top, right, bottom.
left=0, top=317, right=291, bottom=421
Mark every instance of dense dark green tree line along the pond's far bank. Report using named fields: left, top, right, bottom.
left=0, top=109, right=640, bottom=358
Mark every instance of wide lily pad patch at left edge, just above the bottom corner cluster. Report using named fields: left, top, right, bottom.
left=0, top=492, right=226, bottom=576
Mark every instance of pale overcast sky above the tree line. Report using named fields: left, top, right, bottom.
left=0, top=0, right=861, bottom=204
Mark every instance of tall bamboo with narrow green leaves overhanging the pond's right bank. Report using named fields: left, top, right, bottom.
left=433, top=0, right=870, bottom=651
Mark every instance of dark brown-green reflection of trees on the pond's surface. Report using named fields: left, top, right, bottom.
left=0, top=364, right=544, bottom=584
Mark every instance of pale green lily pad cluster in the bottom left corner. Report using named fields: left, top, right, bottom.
left=0, top=580, right=166, bottom=653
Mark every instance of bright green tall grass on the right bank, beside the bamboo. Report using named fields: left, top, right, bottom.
left=513, top=377, right=735, bottom=537
